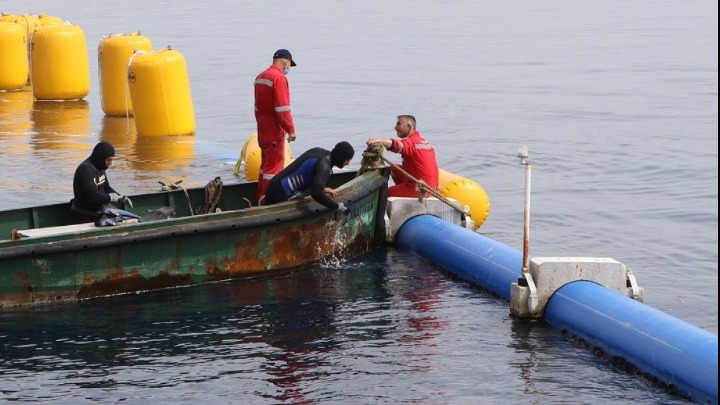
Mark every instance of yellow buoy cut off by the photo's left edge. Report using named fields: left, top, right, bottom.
left=0, top=21, right=29, bottom=90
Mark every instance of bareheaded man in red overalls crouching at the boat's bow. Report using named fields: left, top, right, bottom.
left=366, top=115, right=440, bottom=197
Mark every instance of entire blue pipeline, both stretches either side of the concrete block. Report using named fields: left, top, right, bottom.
left=395, top=215, right=718, bottom=404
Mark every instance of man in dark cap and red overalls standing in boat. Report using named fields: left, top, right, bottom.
left=255, top=49, right=296, bottom=204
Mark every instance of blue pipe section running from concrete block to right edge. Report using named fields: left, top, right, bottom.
left=545, top=281, right=718, bottom=403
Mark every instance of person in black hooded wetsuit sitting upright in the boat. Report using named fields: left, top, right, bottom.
left=70, top=141, right=132, bottom=224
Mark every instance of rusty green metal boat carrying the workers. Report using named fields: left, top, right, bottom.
left=0, top=168, right=389, bottom=310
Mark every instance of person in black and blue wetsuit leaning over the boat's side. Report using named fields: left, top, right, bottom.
left=263, top=141, right=355, bottom=213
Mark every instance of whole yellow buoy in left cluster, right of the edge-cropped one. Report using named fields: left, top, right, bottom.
left=30, top=23, right=90, bottom=100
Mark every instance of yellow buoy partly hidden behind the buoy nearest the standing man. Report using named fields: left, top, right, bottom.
left=98, top=32, right=152, bottom=117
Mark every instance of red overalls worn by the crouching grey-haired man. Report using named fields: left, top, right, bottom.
left=388, top=131, right=440, bottom=197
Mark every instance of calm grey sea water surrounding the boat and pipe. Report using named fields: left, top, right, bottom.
left=0, top=0, right=718, bottom=404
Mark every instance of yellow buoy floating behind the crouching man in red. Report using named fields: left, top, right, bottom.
left=438, top=169, right=490, bottom=229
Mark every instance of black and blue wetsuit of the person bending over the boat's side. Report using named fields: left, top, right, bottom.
left=264, top=148, right=338, bottom=210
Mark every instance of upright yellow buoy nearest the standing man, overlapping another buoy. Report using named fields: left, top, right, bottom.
left=127, top=47, right=195, bottom=136
